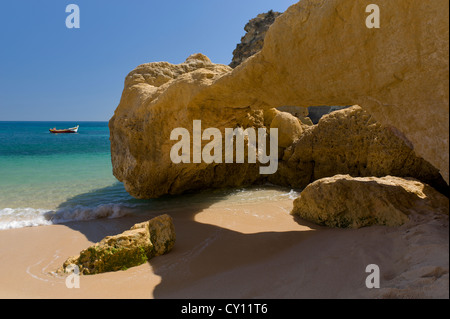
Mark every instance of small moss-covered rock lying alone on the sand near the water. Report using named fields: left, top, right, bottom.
left=59, top=215, right=176, bottom=275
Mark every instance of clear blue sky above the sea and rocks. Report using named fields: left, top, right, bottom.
left=0, top=0, right=297, bottom=121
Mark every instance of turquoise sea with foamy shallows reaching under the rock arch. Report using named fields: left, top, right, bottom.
left=0, top=122, right=297, bottom=230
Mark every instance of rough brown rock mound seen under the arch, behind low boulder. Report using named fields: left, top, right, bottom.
left=268, top=106, right=447, bottom=191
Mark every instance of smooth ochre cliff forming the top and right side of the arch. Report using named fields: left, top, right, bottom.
left=195, top=0, right=449, bottom=183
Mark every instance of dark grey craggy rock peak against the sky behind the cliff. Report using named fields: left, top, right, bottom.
left=230, top=10, right=281, bottom=68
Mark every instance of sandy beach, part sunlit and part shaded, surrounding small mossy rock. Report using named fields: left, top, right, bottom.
left=0, top=200, right=449, bottom=299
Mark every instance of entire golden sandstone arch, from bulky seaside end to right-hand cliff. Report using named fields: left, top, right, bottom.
left=110, top=0, right=449, bottom=198
